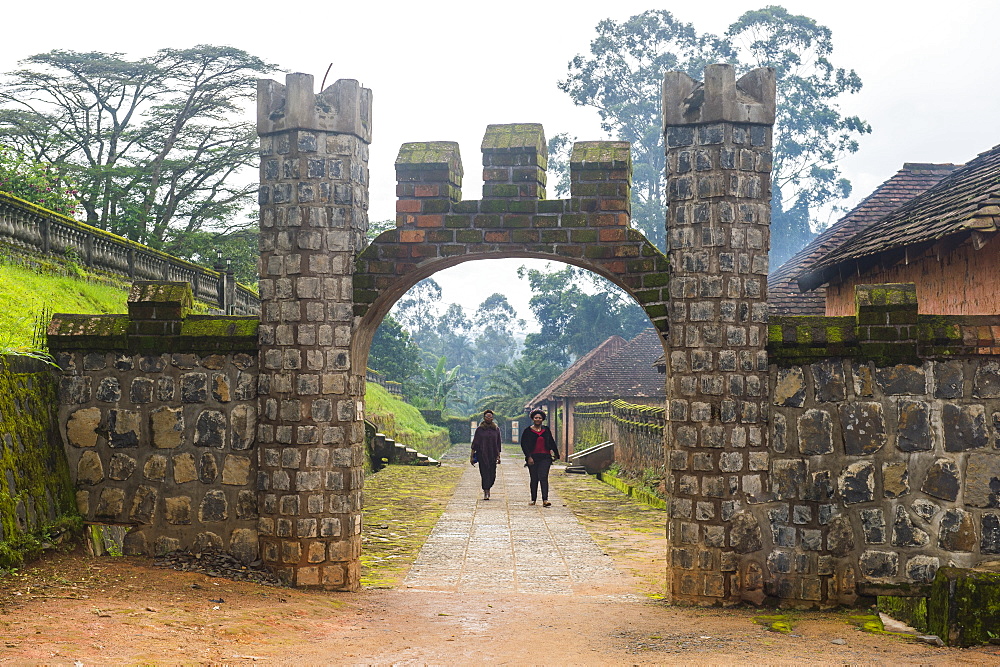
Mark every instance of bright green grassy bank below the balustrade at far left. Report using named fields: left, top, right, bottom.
left=0, top=264, right=128, bottom=347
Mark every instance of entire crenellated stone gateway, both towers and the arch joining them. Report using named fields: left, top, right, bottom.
left=257, top=65, right=774, bottom=603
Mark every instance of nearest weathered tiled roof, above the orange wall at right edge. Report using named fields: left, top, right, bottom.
left=798, top=146, right=1000, bottom=289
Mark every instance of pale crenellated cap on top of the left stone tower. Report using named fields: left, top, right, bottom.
left=257, top=72, right=372, bottom=143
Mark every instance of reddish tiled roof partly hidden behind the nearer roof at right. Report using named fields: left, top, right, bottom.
left=767, top=162, right=957, bottom=315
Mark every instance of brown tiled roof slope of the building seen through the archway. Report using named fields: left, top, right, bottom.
left=553, top=328, right=666, bottom=399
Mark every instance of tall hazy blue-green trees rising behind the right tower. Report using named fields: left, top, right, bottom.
left=559, top=6, right=871, bottom=266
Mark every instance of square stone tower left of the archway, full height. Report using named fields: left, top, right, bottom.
left=257, top=74, right=371, bottom=590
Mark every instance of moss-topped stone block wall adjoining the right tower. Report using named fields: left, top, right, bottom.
left=748, top=284, right=1000, bottom=606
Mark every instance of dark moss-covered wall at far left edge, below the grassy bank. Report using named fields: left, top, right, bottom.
left=0, top=356, right=79, bottom=567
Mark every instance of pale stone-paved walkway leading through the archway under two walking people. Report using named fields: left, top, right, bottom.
left=403, top=450, right=632, bottom=594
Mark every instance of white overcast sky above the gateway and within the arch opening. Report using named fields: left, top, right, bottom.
left=0, top=0, right=1000, bottom=330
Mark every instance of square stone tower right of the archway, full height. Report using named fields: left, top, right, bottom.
left=663, top=65, right=775, bottom=604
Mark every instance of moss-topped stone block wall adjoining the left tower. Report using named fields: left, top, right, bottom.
left=48, top=282, right=258, bottom=562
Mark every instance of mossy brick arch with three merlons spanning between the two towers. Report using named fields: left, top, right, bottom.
left=352, top=124, right=669, bottom=368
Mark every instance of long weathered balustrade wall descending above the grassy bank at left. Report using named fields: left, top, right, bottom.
left=0, top=192, right=260, bottom=315
